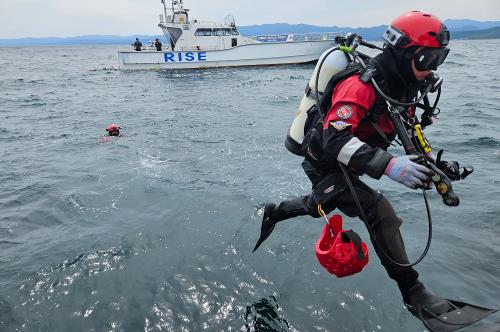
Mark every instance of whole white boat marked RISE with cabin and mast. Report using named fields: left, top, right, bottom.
left=118, top=0, right=333, bottom=69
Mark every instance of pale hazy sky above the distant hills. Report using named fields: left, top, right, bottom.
left=0, top=0, right=500, bottom=38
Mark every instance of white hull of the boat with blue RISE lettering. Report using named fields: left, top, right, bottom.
left=118, top=40, right=332, bottom=70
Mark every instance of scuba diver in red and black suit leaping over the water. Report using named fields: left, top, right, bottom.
left=253, top=11, right=494, bottom=331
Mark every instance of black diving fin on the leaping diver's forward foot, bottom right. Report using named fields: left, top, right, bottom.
left=406, top=283, right=498, bottom=332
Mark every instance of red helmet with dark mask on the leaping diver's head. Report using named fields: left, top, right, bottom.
left=383, top=10, right=450, bottom=70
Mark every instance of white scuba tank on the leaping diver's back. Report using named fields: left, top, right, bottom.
left=285, top=48, right=349, bottom=156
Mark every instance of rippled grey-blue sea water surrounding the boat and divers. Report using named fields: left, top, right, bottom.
left=0, top=40, right=500, bottom=332
